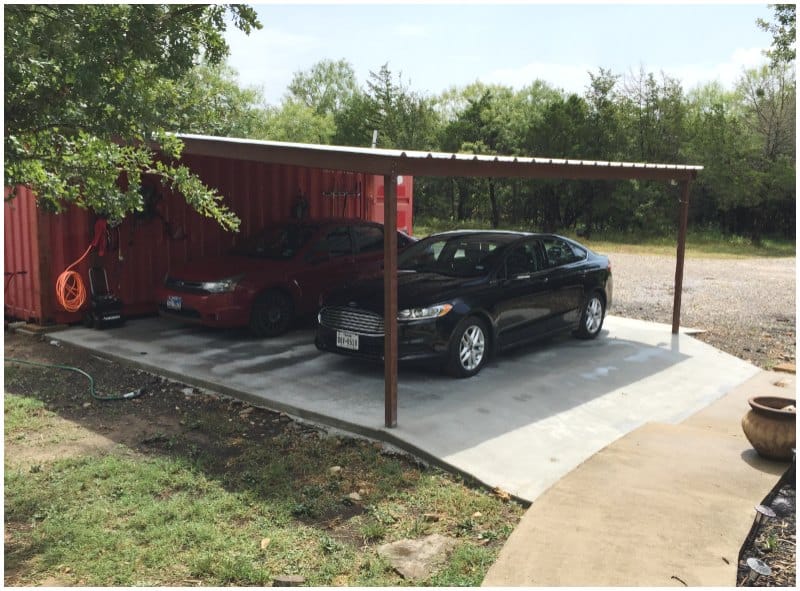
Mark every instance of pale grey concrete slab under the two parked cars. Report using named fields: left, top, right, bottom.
left=50, top=316, right=759, bottom=502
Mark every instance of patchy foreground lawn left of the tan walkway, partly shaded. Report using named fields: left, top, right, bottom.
left=4, top=384, right=523, bottom=586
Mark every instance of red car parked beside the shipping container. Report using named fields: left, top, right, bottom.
left=157, top=219, right=415, bottom=337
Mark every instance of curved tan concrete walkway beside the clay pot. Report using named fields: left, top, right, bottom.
left=483, top=372, right=796, bottom=587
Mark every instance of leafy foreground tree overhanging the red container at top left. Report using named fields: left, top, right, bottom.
left=4, top=4, right=261, bottom=229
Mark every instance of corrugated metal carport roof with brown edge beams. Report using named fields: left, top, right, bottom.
left=176, top=134, right=703, bottom=181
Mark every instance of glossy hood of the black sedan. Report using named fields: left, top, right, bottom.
left=324, top=271, right=486, bottom=314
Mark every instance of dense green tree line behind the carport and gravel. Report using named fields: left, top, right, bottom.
left=175, top=18, right=796, bottom=243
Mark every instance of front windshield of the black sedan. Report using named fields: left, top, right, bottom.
left=397, top=234, right=511, bottom=277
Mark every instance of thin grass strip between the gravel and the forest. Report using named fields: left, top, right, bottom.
left=414, top=216, right=797, bottom=258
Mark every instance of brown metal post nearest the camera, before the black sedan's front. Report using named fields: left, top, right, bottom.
left=383, top=174, right=397, bottom=428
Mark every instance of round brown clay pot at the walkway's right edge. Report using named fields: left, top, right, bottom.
left=742, top=396, right=797, bottom=461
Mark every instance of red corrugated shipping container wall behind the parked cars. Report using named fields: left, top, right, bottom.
left=4, top=155, right=413, bottom=323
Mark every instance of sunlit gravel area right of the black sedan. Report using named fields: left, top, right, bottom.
left=610, top=253, right=796, bottom=369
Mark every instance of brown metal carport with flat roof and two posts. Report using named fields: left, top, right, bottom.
left=178, top=134, right=703, bottom=428
